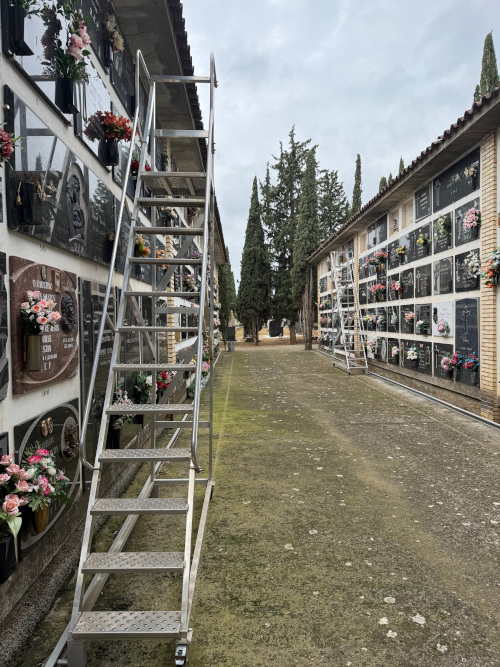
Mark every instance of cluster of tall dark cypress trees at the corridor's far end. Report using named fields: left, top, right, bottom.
left=237, top=127, right=362, bottom=350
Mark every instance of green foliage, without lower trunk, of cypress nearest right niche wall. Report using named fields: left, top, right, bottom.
left=292, top=149, right=320, bottom=305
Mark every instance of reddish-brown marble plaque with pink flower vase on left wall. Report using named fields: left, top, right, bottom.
left=9, top=257, right=78, bottom=394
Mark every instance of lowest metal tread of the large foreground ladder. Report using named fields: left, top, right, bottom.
left=72, top=611, right=181, bottom=639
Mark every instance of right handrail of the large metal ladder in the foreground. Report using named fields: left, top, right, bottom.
left=191, top=53, right=215, bottom=471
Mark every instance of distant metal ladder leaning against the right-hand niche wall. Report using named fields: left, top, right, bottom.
left=330, top=251, right=368, bottom=375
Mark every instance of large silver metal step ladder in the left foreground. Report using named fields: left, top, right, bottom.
left=44, top=51, right=217, bottom=667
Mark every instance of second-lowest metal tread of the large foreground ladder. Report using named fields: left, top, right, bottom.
left=82, top=551, right=184, bottom=574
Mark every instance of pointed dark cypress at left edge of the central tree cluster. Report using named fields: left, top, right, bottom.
left=237, top=177, right=271, bottom=345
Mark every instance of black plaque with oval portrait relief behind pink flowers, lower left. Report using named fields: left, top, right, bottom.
left=14, top=398, right=80, bottom=551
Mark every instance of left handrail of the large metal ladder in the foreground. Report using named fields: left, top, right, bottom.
left=78, top=49, right=149, bottom=474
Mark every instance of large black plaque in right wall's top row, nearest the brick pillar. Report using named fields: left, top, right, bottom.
left=433, top=148, right=480, bottom=212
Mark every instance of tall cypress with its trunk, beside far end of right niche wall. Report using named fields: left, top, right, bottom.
left=292, top=149, right=320, bottom=350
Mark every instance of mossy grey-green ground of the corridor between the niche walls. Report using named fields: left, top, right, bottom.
left=15, top=345, right=500, bottom=667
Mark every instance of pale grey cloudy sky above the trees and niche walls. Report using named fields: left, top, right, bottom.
left=183, top=0, right=500, bottom=279
